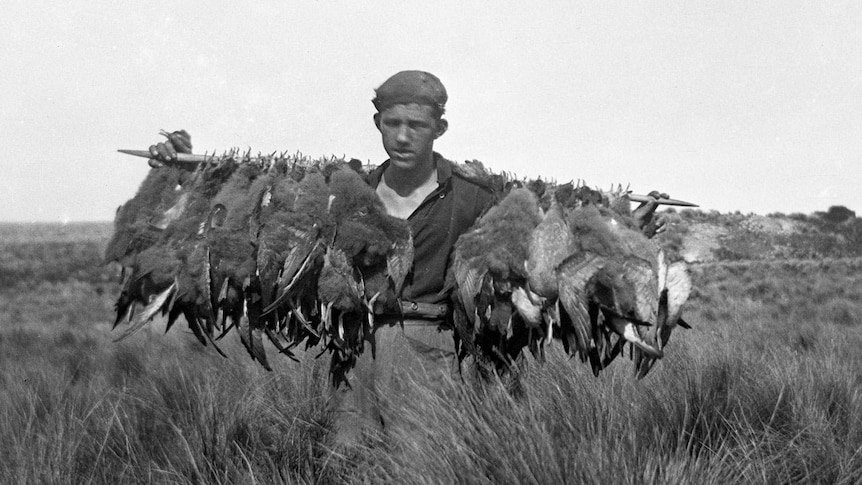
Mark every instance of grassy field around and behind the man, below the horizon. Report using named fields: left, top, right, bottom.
left=0, top=224, right=862, bottom=484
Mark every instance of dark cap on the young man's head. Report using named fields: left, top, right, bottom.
left=371, top=71, right=448, bottom=115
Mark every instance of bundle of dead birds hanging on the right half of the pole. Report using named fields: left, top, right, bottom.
left=449, top=166, right=691, bottom=378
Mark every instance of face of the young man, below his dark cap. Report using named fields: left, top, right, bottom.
left=374, top=103, right=448, bottom=169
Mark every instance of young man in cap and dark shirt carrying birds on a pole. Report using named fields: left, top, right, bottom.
left=150, top=71, right=493, bottom=444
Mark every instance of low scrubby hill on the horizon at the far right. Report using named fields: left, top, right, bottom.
left=659, top=206, right=862, bottom=262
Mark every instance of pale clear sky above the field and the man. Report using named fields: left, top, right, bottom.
left=0, top=0, right=862, bottom=222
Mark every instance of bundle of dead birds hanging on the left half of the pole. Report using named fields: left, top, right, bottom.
left=105, top=149, right=413, bottom=382
